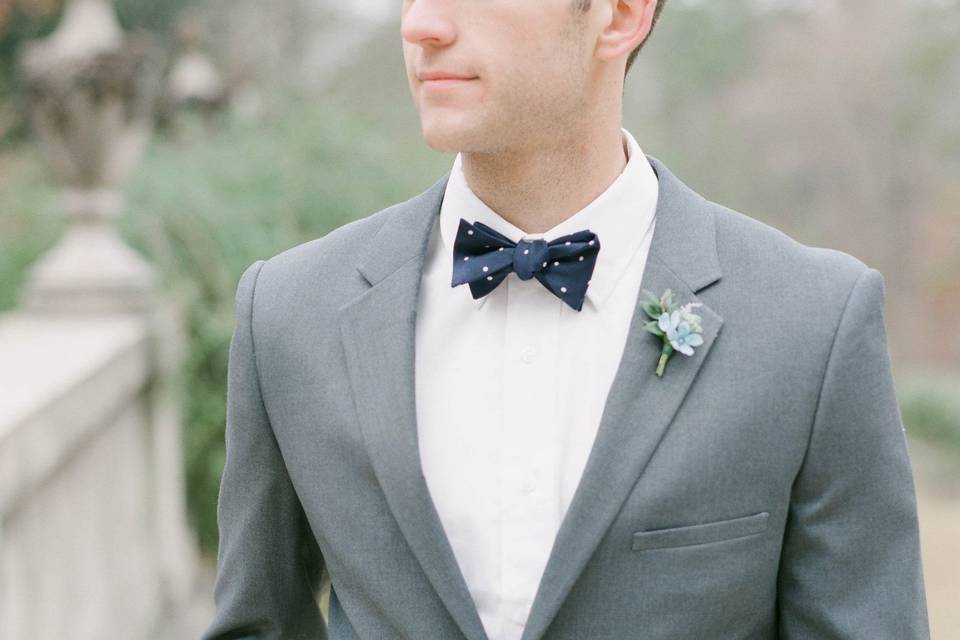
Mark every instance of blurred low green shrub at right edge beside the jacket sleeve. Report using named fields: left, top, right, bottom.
left=897, top=371, right=960, bottom=456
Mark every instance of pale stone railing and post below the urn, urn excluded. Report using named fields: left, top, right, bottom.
left=0, top=302, right=197, bottom=640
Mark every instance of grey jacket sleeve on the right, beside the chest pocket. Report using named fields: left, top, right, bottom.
left=777, top=267, right=929, bottom=640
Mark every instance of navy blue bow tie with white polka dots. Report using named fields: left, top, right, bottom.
left=451, top=218, right=600, bottom=311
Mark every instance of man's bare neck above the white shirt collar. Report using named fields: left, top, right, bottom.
left=462, top=123, right=627, bottom=233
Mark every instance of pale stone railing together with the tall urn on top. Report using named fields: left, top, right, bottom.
left=0, top=0, right=199, bottom=640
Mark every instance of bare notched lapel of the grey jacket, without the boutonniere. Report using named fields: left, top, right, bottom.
left=339, top=177, right=486, bottom=640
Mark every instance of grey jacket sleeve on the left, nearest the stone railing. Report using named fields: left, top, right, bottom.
left=202, top=260, right=327, bottom=640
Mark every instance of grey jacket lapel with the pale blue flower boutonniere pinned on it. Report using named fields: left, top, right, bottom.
left=521, top=156, right=723, bottom=640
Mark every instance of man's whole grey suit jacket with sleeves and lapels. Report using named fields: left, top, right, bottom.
left=203, top=156, right=928, bottom=640
